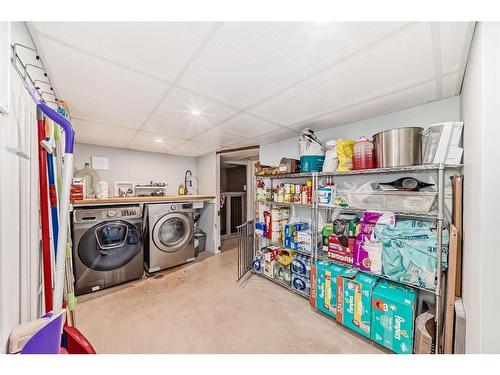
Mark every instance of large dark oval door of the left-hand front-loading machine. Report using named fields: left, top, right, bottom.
left=78, top=220, right=142, bottom=271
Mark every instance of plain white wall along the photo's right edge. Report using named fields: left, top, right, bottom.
left=461, top=23, right=500, bottom=353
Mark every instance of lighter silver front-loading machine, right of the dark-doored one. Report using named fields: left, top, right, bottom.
left=144, top=203, right=195, bottom=274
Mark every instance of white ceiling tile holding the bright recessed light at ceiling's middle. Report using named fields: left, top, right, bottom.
left=144, top=88, right=236, bottom=139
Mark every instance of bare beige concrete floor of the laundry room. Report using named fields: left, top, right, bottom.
left=77, top=244, right=383, bottom=354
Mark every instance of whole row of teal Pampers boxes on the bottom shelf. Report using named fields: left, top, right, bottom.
left=310, top=260, right=416, bottom=353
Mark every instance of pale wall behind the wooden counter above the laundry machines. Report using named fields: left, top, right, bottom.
left=75, top=143, right=198, bottom=195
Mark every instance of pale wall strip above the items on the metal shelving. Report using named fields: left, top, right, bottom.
left=260, top=96, right=460, bottom=166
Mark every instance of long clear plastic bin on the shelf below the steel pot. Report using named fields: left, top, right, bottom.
left=344, top=191, right=437, bottom=213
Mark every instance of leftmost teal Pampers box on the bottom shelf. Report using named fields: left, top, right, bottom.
left=311, top=261, right=350, bottom=318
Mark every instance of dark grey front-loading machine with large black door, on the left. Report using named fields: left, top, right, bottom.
left=73, top=205, right=144, bottom=295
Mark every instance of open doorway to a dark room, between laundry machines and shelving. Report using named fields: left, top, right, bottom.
left=218, top=146, right=259, bottom=251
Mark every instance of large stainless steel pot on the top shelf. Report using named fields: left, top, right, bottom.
left=373, top=127, right=424, bottom=168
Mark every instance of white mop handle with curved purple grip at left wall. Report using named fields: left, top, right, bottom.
left=37, top=101, right=75, bottom=314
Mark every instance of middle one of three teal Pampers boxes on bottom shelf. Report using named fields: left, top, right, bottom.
left=337, top=269, right=378, bottom=338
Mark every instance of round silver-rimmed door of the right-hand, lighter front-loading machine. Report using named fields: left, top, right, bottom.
left=152, top=212, right=193, bottom=253
